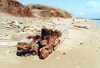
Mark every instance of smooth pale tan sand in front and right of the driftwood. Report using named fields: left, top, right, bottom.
left=0, top=18, right=100, bottom=68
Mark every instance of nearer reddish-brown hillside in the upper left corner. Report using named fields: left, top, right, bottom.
left=0, top=0, right=33, bottom=17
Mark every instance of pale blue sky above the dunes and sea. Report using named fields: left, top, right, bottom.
left=18, top=0, right=100, bottom=19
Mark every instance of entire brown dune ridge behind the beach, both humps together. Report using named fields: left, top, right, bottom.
left=0, top=0, right=72, bottom=18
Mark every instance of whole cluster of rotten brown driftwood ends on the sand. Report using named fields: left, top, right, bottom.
left=17, top=28, right=62, bottom=59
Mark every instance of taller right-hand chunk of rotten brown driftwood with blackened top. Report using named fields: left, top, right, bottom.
left=39, top=29, right=61, bottom=59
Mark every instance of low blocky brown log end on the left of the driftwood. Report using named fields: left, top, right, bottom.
left=17, top=42, right=39, bottom=56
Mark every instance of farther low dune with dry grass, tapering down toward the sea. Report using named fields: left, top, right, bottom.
left=28, top=4, right=72, bottom=18
